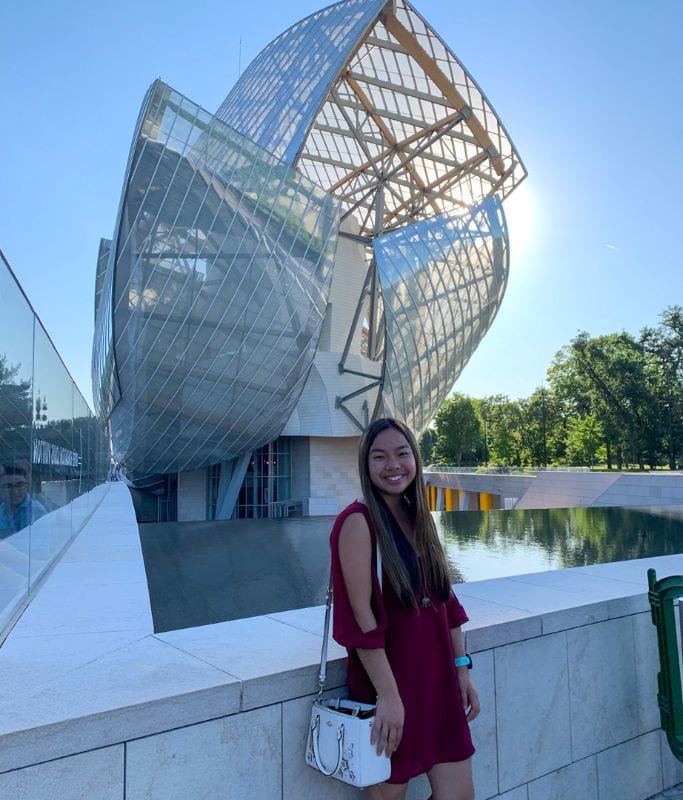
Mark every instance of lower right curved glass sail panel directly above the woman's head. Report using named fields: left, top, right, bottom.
left=374, top=198, right=508, bottom=435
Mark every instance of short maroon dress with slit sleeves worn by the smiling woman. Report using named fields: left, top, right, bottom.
left=330, top=501, right=474, bottom=783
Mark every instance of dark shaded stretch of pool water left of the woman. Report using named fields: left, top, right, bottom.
left=139, top=517, right=333, bottom=633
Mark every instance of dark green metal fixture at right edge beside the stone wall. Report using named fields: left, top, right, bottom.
left=647, top=569, right=683, bottom=761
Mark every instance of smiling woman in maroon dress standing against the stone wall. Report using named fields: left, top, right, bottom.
left=331, top=418, right=479, bottom=800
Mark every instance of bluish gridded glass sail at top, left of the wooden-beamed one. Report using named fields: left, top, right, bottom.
left=216, top=0, right=386, bottom=163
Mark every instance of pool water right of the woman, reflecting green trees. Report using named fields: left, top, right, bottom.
left=435, top=508, right=683, bottom=581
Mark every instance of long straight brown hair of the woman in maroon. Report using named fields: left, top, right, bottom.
left=358, top=417, right=451, bottom=608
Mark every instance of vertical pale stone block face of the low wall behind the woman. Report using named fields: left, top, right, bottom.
left=0, top=596, right=683, bottom=800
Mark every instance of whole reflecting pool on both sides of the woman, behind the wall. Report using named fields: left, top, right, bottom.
left=139, top=508, right=683, bottom=632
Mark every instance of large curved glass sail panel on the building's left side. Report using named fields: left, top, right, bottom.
left=101, top=82, right=339, bottom=473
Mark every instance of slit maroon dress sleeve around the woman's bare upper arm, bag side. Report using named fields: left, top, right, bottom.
left=330, top=504, right=387, bottom=650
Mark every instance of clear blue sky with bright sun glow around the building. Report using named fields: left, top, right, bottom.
left=0, top=0, right=683, bottom=412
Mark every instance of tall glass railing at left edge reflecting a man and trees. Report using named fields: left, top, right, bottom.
left=0, top=252, right=109, bottom=642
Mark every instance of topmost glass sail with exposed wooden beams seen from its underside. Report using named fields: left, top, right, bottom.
left=297, top=0, right=526, bottom=236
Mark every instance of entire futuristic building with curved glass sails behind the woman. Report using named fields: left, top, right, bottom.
left=93, top=0, right=526, bottom=519
